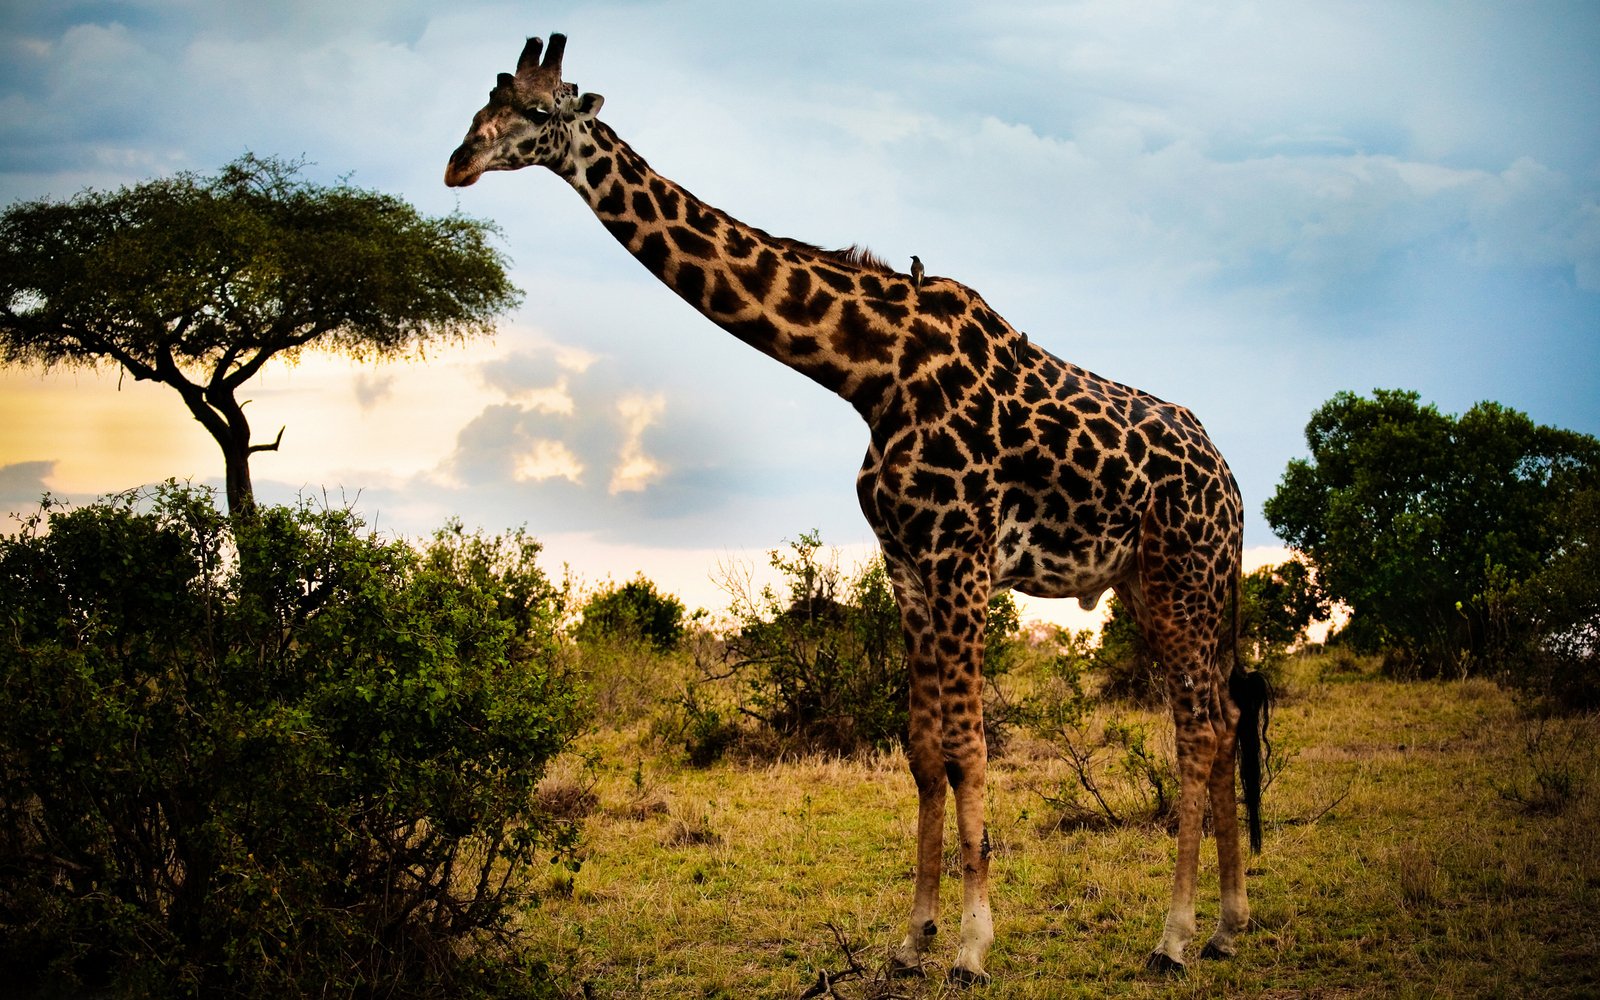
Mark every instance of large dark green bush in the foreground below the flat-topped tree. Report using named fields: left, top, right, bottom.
left=0, top=485, right=579, bottom=997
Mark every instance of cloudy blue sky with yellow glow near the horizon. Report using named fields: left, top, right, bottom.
left=0, top=0, right=1600, bottom=622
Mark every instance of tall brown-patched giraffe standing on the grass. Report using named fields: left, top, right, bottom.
left=445, top=34, right=1266, bottom=986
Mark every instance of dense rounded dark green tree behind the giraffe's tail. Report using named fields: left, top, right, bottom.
left=1264, top=389, right=1600, bottom=674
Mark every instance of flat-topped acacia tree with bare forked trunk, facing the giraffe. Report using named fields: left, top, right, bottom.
left=0, top=154, right=518, bottom=514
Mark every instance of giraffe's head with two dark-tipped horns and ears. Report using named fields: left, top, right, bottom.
left=445, top=35, right=605, bottom=187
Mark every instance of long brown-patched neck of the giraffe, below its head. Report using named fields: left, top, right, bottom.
left=560, top=120, right=910, bottom=419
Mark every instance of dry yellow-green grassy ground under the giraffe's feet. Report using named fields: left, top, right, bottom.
left=525, top=646, right=1600, bottom=1000
